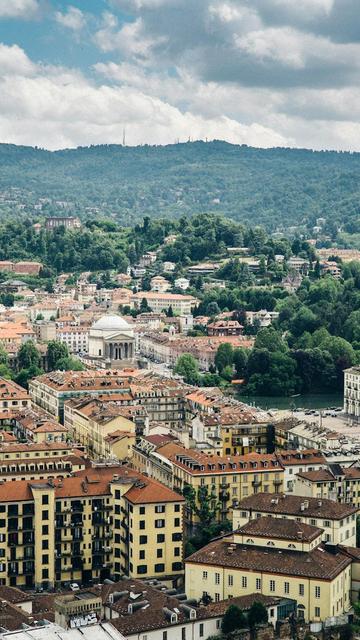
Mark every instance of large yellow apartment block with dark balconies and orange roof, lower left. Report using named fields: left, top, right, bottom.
left=0, top=465, right=183, bottom=589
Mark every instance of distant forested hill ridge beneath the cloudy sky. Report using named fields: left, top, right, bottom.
left=0, top=141, right=360, bottom=232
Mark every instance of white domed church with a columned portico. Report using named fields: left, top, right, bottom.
left=89, top=315, right=135, bottom=369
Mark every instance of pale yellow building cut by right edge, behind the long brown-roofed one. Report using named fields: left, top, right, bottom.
left=294, top=464, right=360, bottom=507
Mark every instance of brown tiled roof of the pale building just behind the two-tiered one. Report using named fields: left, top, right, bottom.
left=237, top=493, right=358, bottom=520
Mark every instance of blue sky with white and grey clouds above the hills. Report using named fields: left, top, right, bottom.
left=0, top=0, right=360, bottom=150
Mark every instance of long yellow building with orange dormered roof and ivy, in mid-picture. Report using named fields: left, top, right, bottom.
left=132, top=440, right=284, bottom=527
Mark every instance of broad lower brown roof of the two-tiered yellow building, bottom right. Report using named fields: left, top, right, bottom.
left=186, top=539, right=351, bottom=580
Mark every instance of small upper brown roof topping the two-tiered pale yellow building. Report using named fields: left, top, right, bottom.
left=236, top=516, right=323, bottom=542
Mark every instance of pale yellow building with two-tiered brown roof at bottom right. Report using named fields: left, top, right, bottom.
left=185, top=517, right=352, bottom=621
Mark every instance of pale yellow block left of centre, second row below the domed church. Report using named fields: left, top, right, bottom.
left=64, top=398, right=136, bottom=460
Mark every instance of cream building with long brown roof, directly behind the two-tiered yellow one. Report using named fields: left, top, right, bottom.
left=233, top=493, right=358, bottom=547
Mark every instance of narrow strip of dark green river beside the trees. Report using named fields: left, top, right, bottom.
left=235, top=393, right=343, bottom=409
